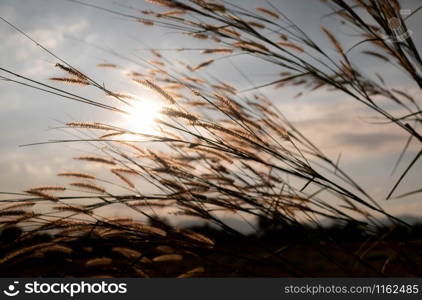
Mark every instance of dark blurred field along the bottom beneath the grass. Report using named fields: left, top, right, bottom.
left=0, top=220, right=422, bottom=277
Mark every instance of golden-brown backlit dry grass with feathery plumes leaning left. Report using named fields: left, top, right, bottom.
left=0, top=0, right=422, bottom=277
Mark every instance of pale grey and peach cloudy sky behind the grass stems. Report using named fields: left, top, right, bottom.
left=0, top=0, right=422, bottom=225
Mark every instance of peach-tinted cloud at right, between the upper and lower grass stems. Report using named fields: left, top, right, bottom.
left=270, top=91, right=414, bottom=161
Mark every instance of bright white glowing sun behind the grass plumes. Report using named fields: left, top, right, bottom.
left=126, top=100, right=161, bottom=134
